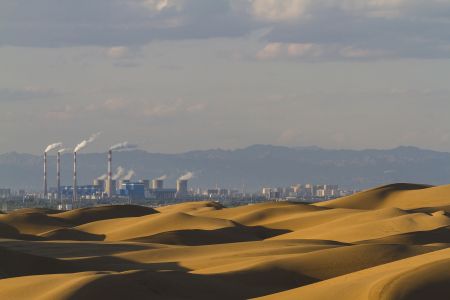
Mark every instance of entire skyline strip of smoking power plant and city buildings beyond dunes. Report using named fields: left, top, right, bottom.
left=0, top=133, right=356, bottom=211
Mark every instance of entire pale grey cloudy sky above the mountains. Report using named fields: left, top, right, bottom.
left=0, top=0, right=450, bottom=154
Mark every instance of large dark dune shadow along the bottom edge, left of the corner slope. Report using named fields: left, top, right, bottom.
left=68, top=269, right=317, bottom=300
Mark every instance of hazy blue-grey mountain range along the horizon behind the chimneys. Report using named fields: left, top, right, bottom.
left=0, top=145, right=450, bottom=190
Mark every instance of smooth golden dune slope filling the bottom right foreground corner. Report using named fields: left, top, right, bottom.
left=260, top=249, right=450, bottom=300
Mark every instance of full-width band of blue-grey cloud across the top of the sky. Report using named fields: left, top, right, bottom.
left=0, top=0, right=450, bottom=59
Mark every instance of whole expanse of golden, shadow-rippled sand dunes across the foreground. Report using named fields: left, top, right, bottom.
left=0, top=184, right=450, bottom=300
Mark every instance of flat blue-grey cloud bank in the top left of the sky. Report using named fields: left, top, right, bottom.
left=0, top=0, right=249, bottom=47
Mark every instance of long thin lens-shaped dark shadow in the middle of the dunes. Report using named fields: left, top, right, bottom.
left=126, top=224, right=290, bottom=246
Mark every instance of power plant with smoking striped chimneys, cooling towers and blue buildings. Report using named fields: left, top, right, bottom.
left=44, top=138, right=193, bottom=209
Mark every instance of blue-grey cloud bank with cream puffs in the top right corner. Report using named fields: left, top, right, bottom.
left=257, top=0, right=450, bottom=60
